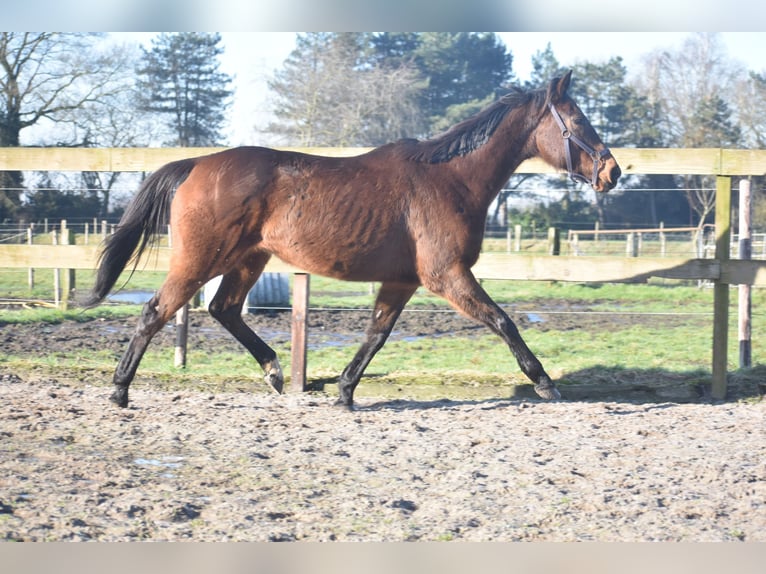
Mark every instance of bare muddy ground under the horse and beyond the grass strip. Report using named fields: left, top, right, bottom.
left=0, top=312, right=766, bottom=541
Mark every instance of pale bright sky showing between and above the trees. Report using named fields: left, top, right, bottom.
left=112, top=32, right=766, bottom=145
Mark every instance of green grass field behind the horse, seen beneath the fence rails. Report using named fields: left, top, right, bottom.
left=0, top=258, right=766, bottom=402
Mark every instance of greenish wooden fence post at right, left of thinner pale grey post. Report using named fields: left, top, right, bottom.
left=710, top=176, right=731, bottom=399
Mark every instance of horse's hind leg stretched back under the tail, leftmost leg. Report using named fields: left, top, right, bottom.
left=110, top=272, right=199, bottom=407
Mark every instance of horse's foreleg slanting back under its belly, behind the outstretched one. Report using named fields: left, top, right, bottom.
left=337, top=283, right=418, bottom=409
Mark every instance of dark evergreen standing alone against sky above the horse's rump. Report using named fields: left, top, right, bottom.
left=138, top=32, right=232, bottom=147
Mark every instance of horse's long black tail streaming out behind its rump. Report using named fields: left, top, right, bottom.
left=83, top=159, right=196, bottom=307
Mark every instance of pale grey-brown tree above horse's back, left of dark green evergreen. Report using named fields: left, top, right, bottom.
left=269, top=33, right=423, bottom=146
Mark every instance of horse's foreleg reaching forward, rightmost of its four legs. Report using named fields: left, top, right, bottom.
left=425, top=268, right=561, bottom=399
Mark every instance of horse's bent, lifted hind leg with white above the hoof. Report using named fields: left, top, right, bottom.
left=208, top=253, right=284, bottom=393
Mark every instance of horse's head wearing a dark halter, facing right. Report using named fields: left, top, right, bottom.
left=536, top=70, right=622, bottom=192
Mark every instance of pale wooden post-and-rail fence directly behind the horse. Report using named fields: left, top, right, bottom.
left=0, top=148, right=766, bottom=399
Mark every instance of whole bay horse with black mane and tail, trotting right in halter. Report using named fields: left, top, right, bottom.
left=85, top=71, right=620, bottom=409
